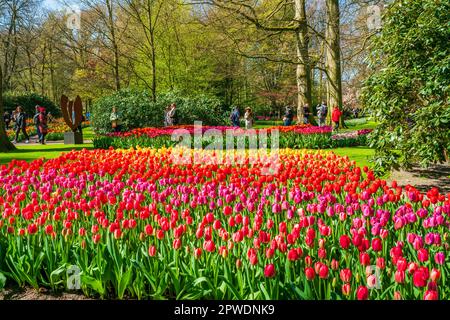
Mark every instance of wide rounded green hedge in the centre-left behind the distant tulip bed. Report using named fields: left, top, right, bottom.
left=91, top=88, right=226, bottom=134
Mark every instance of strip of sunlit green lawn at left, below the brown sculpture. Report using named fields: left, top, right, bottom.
left=0, top=144, right=93, bottom=164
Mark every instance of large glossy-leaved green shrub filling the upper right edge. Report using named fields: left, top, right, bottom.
left=363, top=0, right=450, bottom=170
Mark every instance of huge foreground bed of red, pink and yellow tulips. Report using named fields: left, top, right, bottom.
left=0, top=149, right=450, bottom=299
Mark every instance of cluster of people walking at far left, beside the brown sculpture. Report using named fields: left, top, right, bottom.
left=3, top=105, right=51, bottom=144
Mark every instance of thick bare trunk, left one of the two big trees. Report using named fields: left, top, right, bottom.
left=294, top=0, right=312, bottom=123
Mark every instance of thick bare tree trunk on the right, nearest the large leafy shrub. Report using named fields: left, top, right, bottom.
left=326, top=0, right=343, bottom=126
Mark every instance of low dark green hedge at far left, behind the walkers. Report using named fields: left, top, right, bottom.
left=3, top=92, right=62, bottom=117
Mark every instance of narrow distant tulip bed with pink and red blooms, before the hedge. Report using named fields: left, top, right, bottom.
left=93, top=125, right=367, bottom=149
